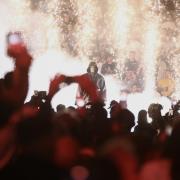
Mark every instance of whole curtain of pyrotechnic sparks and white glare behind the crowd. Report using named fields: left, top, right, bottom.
left=0, top=0, right=180, bottom=114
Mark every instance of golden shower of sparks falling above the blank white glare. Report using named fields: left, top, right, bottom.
left=1, top=0, right=180, bottom=112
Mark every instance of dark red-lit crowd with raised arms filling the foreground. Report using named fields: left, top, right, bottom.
left=0, top=38, right=180, bottom=180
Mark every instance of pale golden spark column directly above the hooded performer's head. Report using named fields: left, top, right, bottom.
left=75, top=0, right=99, bottom=58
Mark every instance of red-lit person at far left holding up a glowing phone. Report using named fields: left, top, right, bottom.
left=0, top=32, right=32, bottom=126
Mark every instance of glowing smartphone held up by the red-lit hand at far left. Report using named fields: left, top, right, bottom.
left=7, top=32, right=23, bottom=45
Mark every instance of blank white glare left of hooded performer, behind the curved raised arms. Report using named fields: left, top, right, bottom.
left=27, top=50, right=87, bottom=108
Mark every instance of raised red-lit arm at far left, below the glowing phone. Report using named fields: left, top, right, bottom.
left=0, top=44, right=32, bottom=106
